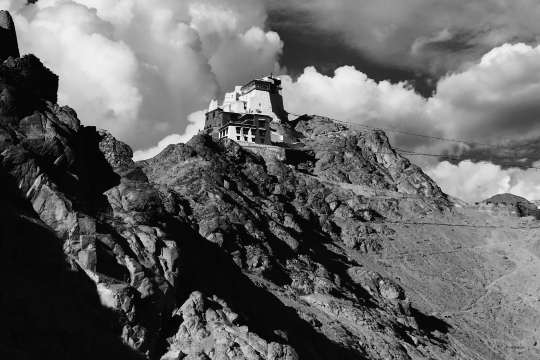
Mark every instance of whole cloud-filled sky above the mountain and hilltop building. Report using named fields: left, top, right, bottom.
left=5, top=0, right=540, bottom=201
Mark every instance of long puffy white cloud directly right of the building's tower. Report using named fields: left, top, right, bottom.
left=282, top=66, right=432, bottom=150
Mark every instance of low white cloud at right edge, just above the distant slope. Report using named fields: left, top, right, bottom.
left=427, top=160, right=540, bottom=202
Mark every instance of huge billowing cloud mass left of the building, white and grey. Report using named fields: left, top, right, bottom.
left=6, top=0, right=283, bottom=149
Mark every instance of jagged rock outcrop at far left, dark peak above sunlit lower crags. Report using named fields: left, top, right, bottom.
left=0, top=47, right=177, bottom=357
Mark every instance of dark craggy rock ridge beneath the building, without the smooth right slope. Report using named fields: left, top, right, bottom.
left=0, top=56, right=535, bottom=360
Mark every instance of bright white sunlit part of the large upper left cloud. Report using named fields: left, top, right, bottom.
left=17, top=2, right=142, bottom=133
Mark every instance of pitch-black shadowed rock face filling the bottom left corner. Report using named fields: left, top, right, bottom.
left=0, top=172, right=144, bottom=360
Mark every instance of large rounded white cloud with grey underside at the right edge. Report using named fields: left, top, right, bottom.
left=428, top=44, right=540, bottom=141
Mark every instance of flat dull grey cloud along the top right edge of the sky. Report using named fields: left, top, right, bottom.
left=269, top=0, right=540, bottom=74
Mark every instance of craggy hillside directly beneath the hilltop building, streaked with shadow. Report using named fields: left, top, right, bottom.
left=142, top=123, right=456, bottom=359
